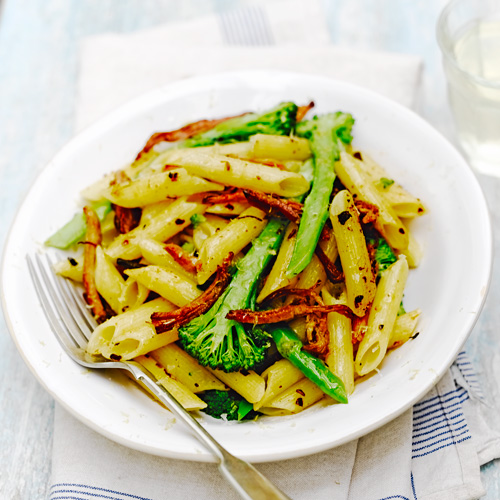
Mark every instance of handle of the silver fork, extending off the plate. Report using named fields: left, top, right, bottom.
left=126, top=362, right=290, bottom=500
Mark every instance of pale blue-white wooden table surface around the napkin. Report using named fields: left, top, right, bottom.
left=0, top=0, right=500, bottom=500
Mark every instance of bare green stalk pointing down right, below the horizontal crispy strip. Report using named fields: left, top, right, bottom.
left=268, top=323, right=347, bottom=403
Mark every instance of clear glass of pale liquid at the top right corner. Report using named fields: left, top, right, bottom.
left=437, top=0, right=500, bottom=177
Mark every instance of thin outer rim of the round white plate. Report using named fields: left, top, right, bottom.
left=0, top=70, right=493, bottom=462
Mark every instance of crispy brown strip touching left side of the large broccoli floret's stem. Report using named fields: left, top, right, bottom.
left=151, top=253, right=233, bottom=333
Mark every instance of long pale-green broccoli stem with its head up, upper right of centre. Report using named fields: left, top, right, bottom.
left=287, top=111, right=354, bottom=277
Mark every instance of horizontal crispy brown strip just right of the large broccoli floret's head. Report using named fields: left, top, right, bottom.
left=226, top=304, right=355, bottom=325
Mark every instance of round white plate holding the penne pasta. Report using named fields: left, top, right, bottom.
left=2, top=72, right=492, bottom=462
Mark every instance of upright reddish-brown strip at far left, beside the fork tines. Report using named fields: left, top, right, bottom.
left=83, top=206, right=107, bottom=323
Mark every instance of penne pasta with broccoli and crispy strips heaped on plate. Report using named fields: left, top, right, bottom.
left=46, top=102, right=425, bottom=420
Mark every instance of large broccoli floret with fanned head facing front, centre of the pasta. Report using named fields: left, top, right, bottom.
left=179, top=218, right=287, bottom=372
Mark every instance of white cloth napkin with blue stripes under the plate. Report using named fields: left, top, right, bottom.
left=50, top=0, right=500, bottom=500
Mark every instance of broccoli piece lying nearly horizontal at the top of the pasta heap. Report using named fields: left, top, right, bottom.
left=183, top=102, right=297, bottom=147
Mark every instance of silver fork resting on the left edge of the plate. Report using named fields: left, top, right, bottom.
left=26, top=254, right=290, bottom=500
